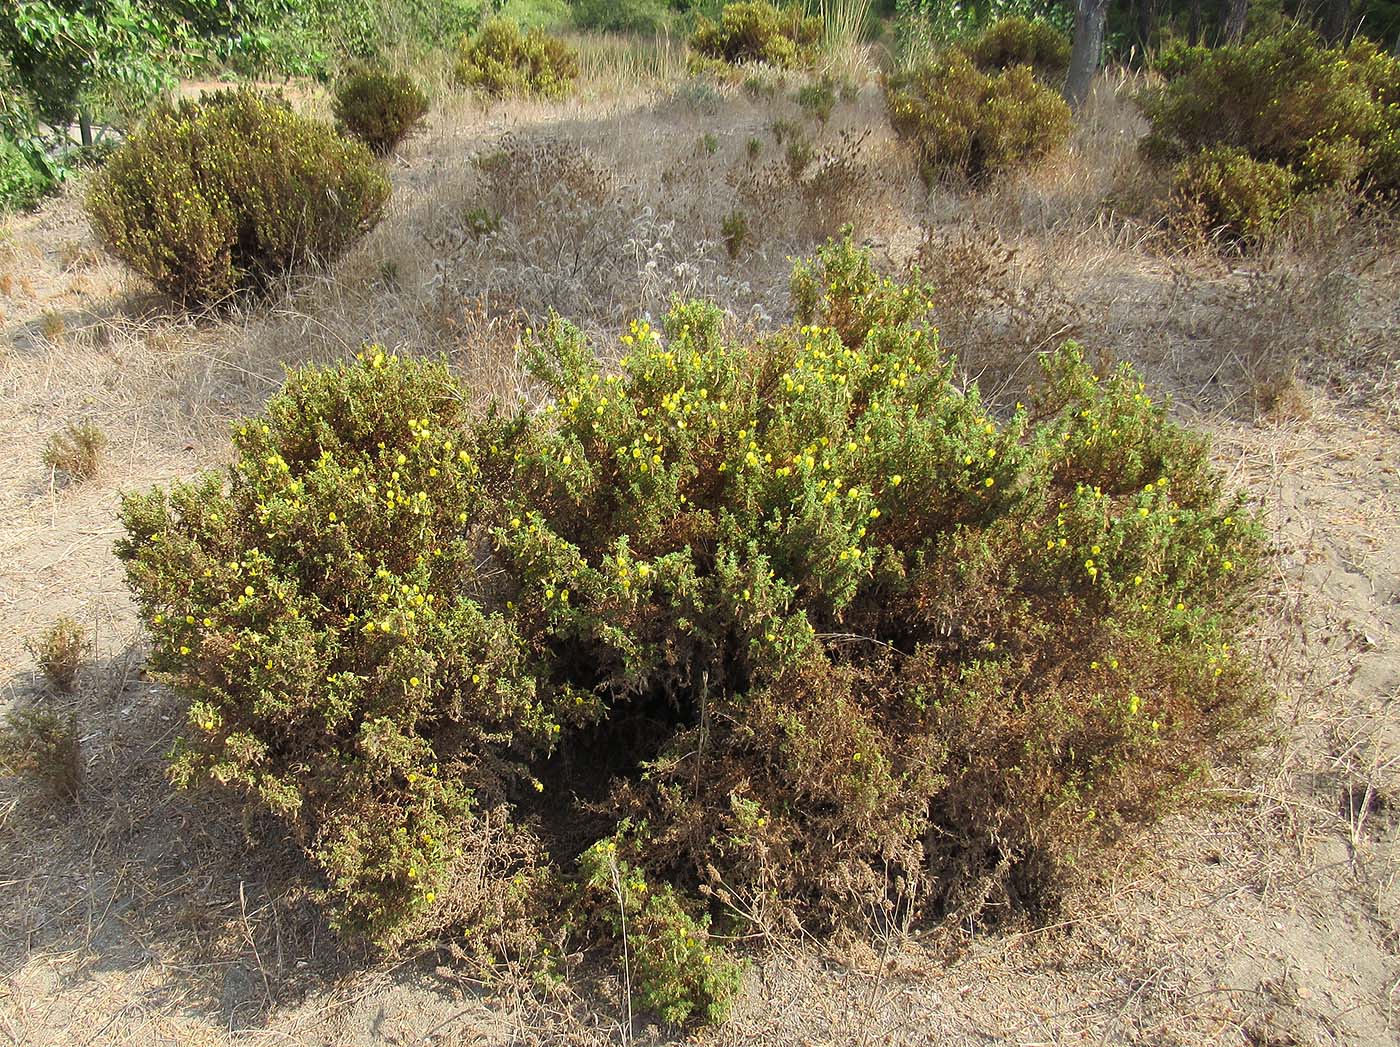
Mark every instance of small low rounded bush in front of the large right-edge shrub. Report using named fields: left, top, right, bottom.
left=1172, top=146, right=1299, bottom=239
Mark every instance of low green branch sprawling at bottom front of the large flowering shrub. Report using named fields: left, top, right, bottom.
left=578, top=840, right=742, bottom=1025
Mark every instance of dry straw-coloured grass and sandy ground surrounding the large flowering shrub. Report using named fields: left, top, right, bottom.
left=0, top=59, right=1400, bottom=1047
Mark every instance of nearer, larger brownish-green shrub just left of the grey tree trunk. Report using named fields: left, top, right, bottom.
left=885, top=50, right=1070, bottom=179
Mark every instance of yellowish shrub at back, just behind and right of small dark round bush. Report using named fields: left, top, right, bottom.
left=455, top=18, right=578, bottom=98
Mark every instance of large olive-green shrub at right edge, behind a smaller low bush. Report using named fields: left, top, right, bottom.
left=1140, top=28, right=1400, bottom=200
